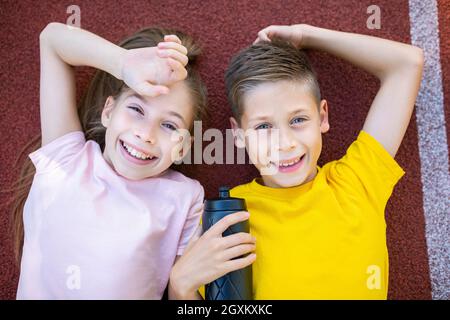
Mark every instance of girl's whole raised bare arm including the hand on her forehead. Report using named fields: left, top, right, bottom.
left=39, top=23, right=187, bottom=146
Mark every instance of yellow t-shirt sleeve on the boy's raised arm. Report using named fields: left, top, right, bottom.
left=329, top=131, right=405, bottom=211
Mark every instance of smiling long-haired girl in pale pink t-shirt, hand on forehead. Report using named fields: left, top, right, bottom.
left=9, top=23, right=253, bottom=299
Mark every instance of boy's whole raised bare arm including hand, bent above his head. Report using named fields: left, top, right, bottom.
left=258, top=24, right=424, bottom=157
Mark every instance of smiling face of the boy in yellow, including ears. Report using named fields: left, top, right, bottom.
left=230, top=80, right=329, bottom=188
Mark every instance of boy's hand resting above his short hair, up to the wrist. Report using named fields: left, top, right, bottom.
left=253, top=24, right=306, bottom=49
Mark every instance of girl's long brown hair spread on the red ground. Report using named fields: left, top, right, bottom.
left=4, top=27, right=206, bottom=265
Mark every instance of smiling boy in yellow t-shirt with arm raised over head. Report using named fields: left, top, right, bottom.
left=225, top=24, right=423, bottom=299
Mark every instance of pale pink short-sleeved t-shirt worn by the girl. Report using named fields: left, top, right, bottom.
left=17, top=131, right=204, bottom=299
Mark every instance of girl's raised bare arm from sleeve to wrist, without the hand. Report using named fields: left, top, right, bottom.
left=39, top=23, right=125, bottom=146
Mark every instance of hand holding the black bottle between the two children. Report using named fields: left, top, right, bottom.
left=170, top=211, right=256, bottom=297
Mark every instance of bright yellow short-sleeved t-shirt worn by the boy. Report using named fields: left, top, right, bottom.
left=203, top=131, right=405, bottom=299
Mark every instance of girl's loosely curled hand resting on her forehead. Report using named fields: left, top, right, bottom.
left=122, top=35, right=188, bottom=97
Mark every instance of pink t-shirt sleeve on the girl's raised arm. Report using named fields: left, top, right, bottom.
left=28, top=131, right=86, bottom=173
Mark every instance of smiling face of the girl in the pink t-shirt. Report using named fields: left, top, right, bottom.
left=102, top=81, right=193, bottom=180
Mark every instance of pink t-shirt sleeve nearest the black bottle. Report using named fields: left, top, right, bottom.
left=177, top=181, right=205, bottom=255
